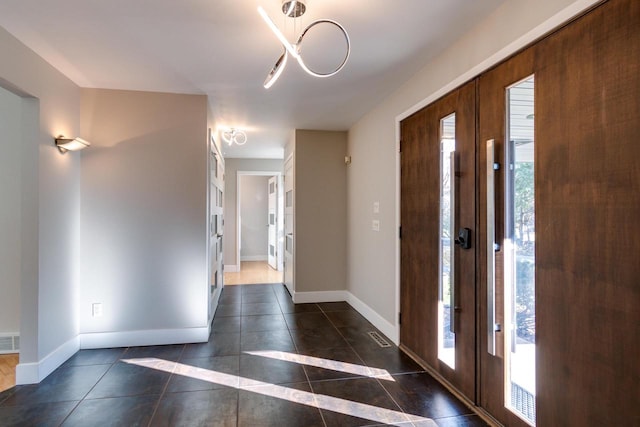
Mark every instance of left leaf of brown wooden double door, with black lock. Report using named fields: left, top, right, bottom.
left=400, top=81, right=476, bottom=401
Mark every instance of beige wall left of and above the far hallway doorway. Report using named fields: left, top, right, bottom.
left=223, top=159, right=283, bottom=266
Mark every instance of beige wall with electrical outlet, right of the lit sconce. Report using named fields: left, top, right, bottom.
left=79, top=89, right=208, bottom=338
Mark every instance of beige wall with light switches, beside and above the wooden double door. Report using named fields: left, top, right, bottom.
left=347, top=0, right=596, bottom=325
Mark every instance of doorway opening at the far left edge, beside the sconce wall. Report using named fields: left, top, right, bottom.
left=0, top=80, right=40, bottom=392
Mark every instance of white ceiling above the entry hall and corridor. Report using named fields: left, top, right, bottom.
left=0, top=0, right=504, bottom=158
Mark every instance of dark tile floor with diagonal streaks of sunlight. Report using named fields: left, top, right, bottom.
left=0, top=285, right=485, bottom=427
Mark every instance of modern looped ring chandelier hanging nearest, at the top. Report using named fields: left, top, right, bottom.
left=258, top=0, right=351, bottom=89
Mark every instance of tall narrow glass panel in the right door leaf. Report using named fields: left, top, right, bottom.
left=504, top=76, right=536, bottom=424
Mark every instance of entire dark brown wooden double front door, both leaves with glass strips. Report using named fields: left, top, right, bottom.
left=400, top=0, right=640, bottom=426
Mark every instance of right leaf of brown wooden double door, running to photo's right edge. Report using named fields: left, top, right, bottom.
left=478, top=0, right=640, bottom=426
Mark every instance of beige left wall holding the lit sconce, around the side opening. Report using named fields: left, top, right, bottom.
left=0, top=24, right=82, bottom=382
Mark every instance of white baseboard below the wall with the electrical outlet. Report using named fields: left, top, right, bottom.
left=80, top=325, right=209, bottom=349
